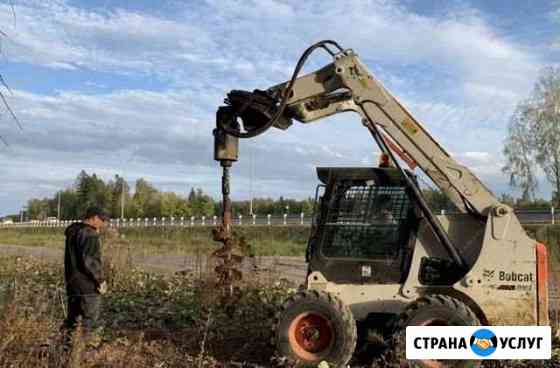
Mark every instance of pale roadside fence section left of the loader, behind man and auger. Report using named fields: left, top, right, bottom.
left=0, top=213, right=311, bottom=228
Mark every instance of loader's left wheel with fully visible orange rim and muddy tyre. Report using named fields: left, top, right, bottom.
left=272, top=290, right=357, bottom=367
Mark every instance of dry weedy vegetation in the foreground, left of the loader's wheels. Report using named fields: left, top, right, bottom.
left=0, top=249, right=289, bottom=368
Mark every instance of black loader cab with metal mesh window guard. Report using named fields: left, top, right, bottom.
left=307, top=167, right=419, bottom=284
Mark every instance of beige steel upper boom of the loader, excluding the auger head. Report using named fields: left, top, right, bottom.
left=267, top=50, right=501, bottom=216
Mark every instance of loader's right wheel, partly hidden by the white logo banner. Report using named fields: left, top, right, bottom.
left=391, top=294, right=480, bottom=368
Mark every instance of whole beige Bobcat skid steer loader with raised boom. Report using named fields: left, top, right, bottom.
left=214, top=41, right=548, bottom=367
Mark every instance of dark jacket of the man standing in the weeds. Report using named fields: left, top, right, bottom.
left=64, top=222, right=103, bottom=296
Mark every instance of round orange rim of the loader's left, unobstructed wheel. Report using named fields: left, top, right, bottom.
left=288, top=312, right=334, bottom=361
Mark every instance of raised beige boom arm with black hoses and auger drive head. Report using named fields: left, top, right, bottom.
left=215, top=40, right=515, bottom=269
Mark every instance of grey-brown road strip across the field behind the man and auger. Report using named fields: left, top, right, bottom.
left=0, top=244, right=306, bottom=284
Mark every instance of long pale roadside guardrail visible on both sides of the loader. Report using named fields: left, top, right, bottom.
left=0, top=208, right=560, bottom=228
